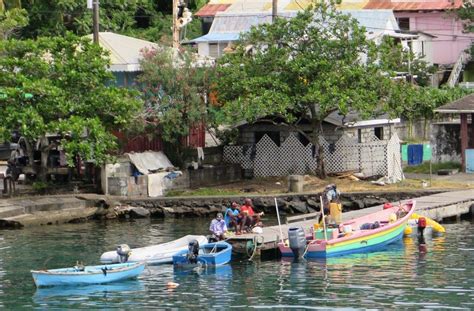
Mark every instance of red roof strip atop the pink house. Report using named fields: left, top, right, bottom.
left=364, top=0, right=462, bottom=11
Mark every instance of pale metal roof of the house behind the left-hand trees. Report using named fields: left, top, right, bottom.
left=86, top=32, right=159, bottom=72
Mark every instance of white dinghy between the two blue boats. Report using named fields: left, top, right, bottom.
left=100, top=235, right=207, bottom=265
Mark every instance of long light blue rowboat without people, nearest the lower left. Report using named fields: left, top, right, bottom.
left=31, top=262, right=145, bottom=287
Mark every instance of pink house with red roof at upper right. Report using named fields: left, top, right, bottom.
left=363, top=0, right=474, bottom=67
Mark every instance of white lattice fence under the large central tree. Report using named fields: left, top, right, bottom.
left=224, top=134, right=403, bottom=180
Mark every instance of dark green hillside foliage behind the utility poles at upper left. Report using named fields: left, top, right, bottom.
left=17, top=0, right=205, bottom=42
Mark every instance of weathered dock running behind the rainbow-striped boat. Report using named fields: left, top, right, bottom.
left=227, top=189, right=474, bottom=255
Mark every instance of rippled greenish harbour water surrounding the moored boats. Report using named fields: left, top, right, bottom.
left=0, top=219, right=474, bottom=310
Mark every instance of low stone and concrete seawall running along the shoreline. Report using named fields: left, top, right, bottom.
left=0, top=190, right=474, bottom=228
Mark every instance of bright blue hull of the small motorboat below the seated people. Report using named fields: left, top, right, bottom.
left=173, top=242, right=232, bottom=267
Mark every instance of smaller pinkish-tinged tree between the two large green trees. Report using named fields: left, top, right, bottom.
left=139, top=49, right=213, bottom=166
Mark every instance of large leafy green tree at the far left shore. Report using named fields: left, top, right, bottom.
left=0, top=34, right=141, bottom=179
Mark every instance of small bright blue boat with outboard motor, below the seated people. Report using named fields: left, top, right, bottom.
left=173, top=242, right=232, bottom=266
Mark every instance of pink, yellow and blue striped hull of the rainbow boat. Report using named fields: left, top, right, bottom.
left=278, top=201, right=415, bottom=258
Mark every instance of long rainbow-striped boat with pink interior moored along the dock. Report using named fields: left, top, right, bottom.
left=278, top=200, right=416, bottom=258
